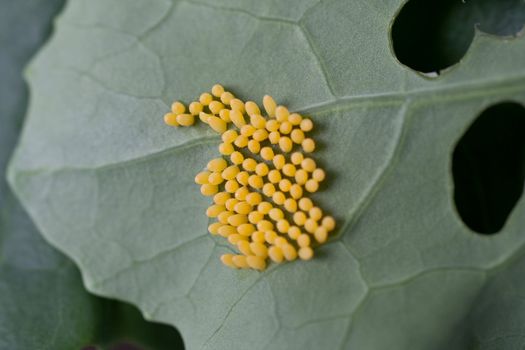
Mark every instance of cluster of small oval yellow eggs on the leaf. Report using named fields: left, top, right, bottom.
left=164, top=84, right=335, bottom=270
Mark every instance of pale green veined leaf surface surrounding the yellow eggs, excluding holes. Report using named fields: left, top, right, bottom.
left=9, top=0, right=525, bottom=350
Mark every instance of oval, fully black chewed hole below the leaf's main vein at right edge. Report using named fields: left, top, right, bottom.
left=452, top=102, right=525, bottom=234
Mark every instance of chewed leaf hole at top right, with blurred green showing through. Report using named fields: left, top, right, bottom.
left=391, top=0, right=525, bottom=76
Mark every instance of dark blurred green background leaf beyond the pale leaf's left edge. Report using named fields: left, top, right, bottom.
left=0, top=0, right=183, bottom=350
